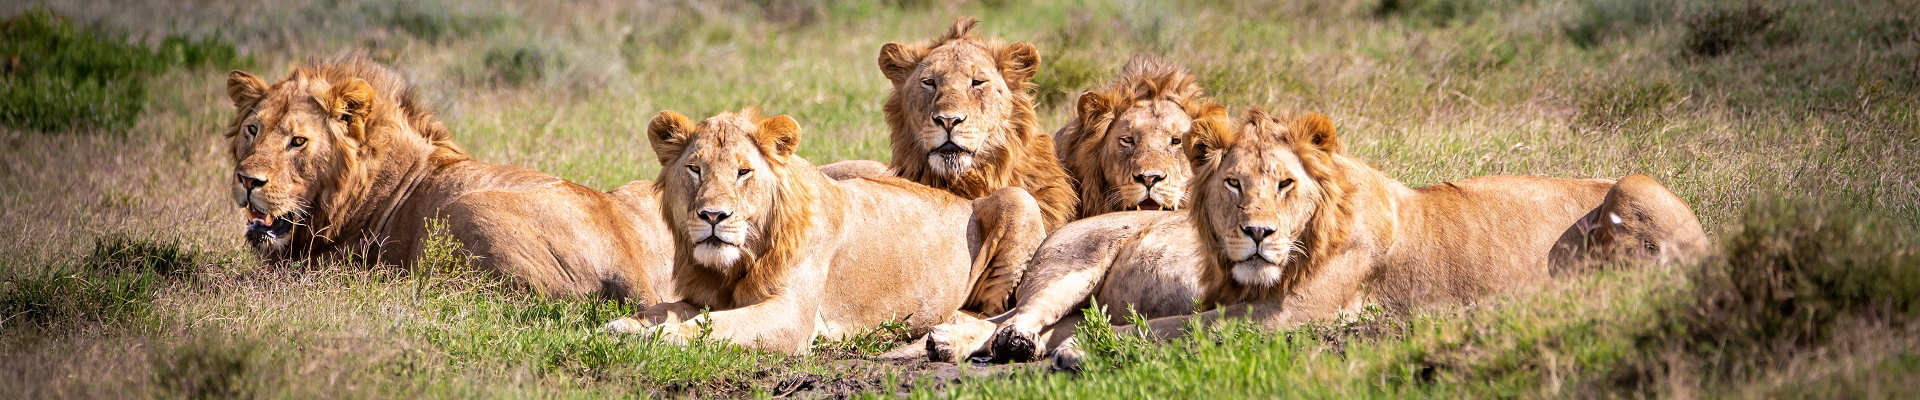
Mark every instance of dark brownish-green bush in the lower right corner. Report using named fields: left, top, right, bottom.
left=1617, top=200, right=1920, bottom=387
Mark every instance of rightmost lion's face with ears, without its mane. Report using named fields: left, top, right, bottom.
left=1192, top=112, right=1332, bottom=287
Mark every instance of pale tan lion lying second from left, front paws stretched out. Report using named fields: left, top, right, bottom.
left=607, top=108, right=1046, bottom=354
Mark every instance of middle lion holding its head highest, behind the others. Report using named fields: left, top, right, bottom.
left=879, top=17, right=1077, bottom=229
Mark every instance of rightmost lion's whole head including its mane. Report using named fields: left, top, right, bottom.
left=1187, top=110, right=1354, bottom=304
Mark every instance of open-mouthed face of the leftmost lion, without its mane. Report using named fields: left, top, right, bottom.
left=225, top=71, right=371, bottom=254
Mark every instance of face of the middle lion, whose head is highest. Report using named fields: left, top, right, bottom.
left=879, top=21, right=1041, bottom=177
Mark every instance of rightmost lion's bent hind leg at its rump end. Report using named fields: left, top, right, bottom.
left=1548, top=175, right=1707, bottom=275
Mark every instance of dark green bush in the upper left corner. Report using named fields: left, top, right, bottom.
left=0, top=8, right=240, bottom=133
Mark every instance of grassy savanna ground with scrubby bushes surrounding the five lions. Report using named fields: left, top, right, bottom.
left=0, top=0, right=1920, bottom=398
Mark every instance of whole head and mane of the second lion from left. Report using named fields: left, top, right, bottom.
left=647, top=110, right=818, bottom=306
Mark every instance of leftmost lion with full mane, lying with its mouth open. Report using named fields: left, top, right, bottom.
left=223, top=56, right=672, bottom=304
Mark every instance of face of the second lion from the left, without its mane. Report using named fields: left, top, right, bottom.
left=649, top=112, right=799, bottom=271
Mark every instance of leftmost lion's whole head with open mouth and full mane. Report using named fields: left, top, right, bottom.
left=225, top=56, right=463, bottom=258
